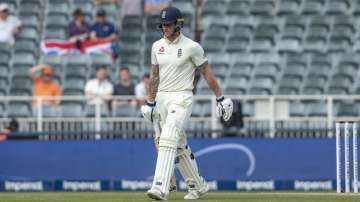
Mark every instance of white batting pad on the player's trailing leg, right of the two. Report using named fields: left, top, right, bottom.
left=175, top=146, right=204, bottom=190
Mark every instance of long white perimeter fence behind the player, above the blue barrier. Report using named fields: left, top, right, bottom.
left=0, top=95, right=360, bottom=139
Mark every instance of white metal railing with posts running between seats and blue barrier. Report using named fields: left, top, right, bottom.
left=0, top=95, right=360, bottom=139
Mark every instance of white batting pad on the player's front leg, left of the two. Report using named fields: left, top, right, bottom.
left=153, top=124, right=179, bottom=194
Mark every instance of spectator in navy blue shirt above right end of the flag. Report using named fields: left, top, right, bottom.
left=90, top=9, right=116, bottom=40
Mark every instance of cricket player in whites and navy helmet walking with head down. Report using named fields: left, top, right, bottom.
left=141, top=7, right=233, bottom=200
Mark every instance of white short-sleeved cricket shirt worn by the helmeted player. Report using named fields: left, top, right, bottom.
left=151, top=34, right=207, bottom=92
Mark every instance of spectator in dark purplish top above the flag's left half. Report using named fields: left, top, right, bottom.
left=67, top=8, right=90, bottom=42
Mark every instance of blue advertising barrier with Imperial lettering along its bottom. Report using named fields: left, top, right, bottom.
left=0, top=138, right=358, bottom=191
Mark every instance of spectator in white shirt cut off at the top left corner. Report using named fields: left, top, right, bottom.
left=0, top=3, right=21, bottom=45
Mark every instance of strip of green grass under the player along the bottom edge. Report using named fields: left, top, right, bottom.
left=0, top=192, right=360, bottom=202
